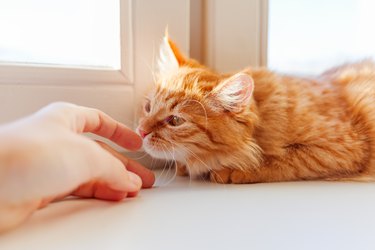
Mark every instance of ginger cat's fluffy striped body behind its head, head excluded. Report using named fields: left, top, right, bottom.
left=218, top=62, right=375, bottom=183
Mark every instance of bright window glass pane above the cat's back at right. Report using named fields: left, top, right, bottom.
left=268, top=0, right=375, bottom=74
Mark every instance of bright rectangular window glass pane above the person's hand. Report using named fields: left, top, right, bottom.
left=0, top=0, right=120, bottom=69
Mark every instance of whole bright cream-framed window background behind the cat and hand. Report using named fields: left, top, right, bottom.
left=0, top=0, right=375, bottom=127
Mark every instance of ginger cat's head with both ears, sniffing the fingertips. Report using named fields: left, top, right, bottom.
left=137, top=32, right=257, bottom=174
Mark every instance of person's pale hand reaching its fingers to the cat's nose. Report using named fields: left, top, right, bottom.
left=0, top=103, right=154, bottom=232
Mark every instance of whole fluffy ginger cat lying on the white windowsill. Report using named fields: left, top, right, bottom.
left=138, top=36, right=375, bottom=183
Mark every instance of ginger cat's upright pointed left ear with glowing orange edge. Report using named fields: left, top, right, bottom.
left=157, top=29, right=186, bottom=75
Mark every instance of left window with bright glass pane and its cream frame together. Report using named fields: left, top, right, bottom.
left=0, top=0, right=190, bottom=133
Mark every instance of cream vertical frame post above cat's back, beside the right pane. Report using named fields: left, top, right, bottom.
left=203, top=0, right=268, bottom=72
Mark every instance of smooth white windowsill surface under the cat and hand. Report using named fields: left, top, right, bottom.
left=0, top=172, right=375, bottom=249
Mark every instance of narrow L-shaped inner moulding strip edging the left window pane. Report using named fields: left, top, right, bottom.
left=0, top=0, right=133, bottom=86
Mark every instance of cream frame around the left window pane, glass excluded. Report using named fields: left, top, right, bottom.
left=0, top=0, right=190, bottom=128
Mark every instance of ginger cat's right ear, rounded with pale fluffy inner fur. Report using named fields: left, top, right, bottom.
left=212, top=73, right=254, bottom=112
